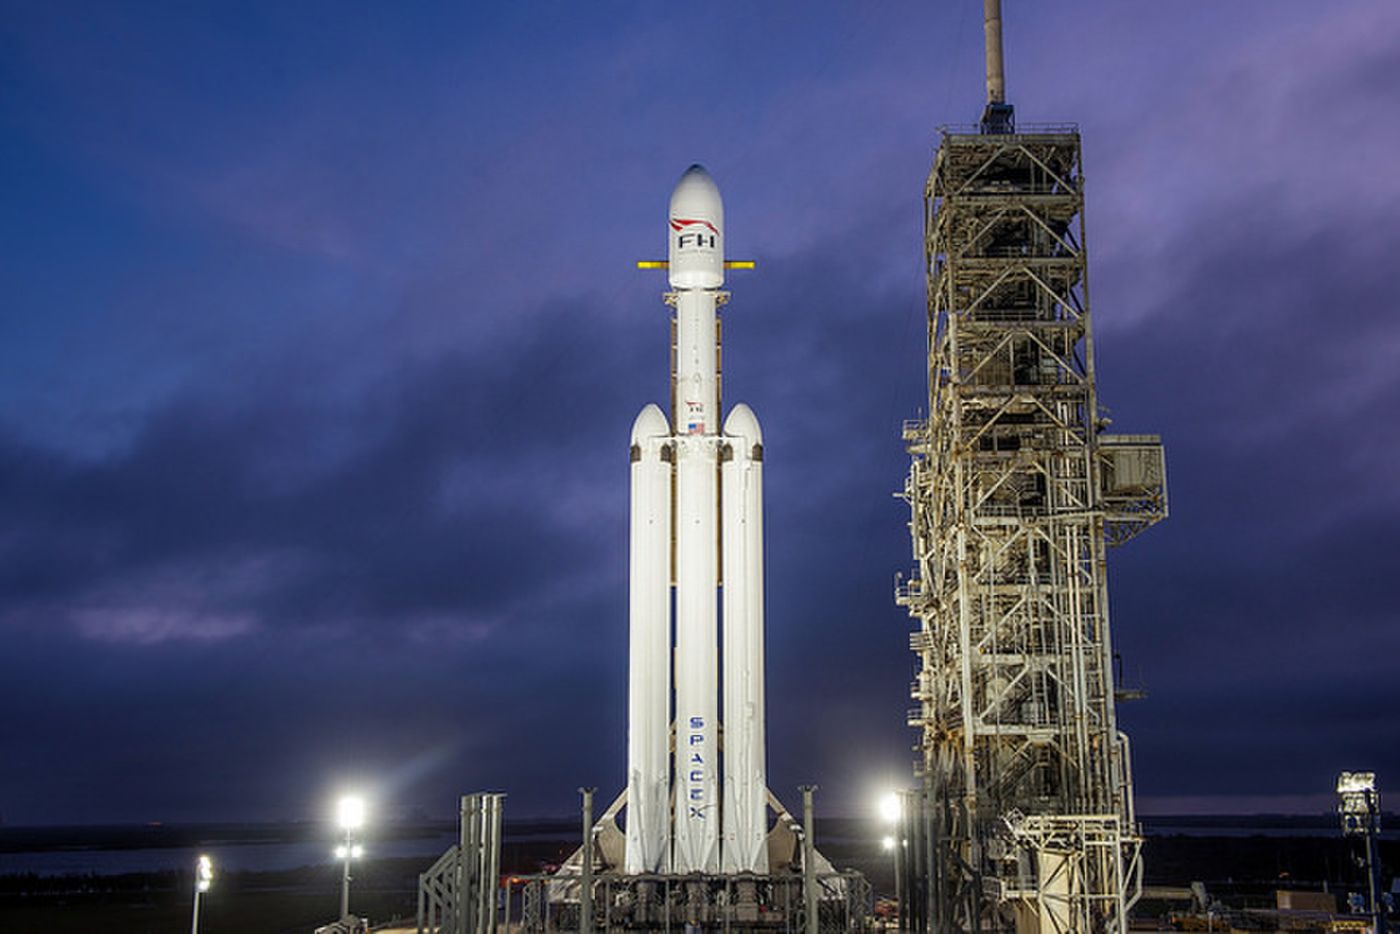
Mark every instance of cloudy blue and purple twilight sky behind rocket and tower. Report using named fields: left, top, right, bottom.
left=0, top=0, right=1400, bottom=823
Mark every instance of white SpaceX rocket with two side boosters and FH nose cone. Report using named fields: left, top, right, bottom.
left=626, top=165, right=769, bottom=872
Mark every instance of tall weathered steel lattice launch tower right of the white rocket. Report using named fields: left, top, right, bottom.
left=896, top=120, right=1166, bottom=931
